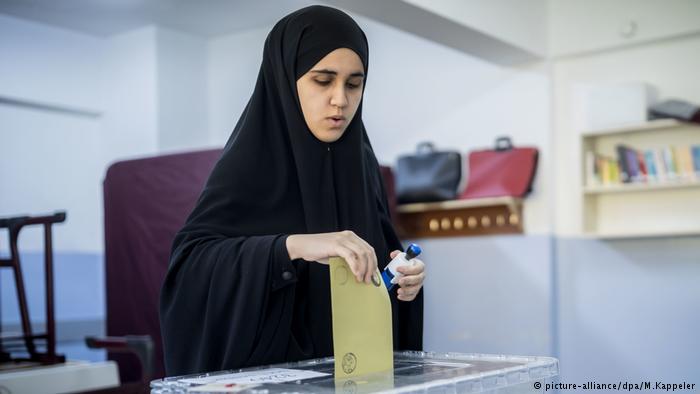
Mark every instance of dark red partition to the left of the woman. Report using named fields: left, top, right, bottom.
left=104, top=149, right=221, bottom=382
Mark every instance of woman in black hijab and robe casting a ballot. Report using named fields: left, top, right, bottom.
left=160, top=6, right=424, bottom=375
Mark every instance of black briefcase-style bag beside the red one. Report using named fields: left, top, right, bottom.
left=396, top=142, right=462, bottom=204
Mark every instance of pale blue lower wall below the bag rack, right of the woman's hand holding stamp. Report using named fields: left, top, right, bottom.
left=422, top=235, right=556, bottom=356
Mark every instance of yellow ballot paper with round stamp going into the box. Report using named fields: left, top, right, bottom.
left=329, top=257, right=394, bottom=379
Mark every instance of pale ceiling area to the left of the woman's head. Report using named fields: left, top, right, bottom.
left=0, top=0, right=318, bottom=37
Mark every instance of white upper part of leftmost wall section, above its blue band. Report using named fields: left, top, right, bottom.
left=0, top=16, right=104, bottom=251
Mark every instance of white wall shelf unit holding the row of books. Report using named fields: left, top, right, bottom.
left=579, top=115, right=700, bottom=240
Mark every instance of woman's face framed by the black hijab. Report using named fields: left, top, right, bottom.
left=297, top=48, right=365, bottom=142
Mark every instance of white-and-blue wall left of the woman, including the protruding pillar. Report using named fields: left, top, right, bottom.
left=0, top=16, right=210, bottom=338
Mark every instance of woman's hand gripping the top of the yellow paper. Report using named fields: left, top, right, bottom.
left=287, top=230, right=377, bottom=283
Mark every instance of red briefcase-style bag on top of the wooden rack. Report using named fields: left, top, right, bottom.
left=460, top=137, right=538, bottom=198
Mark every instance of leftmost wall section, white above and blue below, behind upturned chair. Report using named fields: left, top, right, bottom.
left=0, top=16, right=106, bottom=338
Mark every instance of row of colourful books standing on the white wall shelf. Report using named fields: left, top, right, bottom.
left=585, top=144, right=700, bottom=186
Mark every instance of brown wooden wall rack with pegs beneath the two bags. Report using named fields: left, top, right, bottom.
left=397, top=197, right=523, bottom=238
